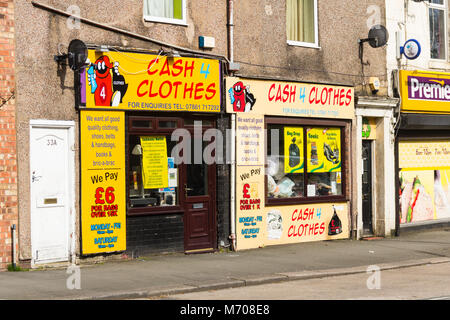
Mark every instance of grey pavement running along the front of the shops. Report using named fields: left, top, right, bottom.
left=0, top=227, right=450, bottom=300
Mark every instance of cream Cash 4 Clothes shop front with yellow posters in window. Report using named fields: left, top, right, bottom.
left=226, top=77, right=355, bottom=250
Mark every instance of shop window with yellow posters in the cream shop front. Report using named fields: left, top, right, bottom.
left=266, top=120, right=345, bottom=204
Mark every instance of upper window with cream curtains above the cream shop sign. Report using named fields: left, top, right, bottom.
left=286, top=0, right=319, bottom=47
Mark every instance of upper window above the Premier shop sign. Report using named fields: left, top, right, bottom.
left=428, top=0, right=447, bottom=60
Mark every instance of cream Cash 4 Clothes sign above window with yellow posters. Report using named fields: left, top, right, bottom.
left=226, top=77, right=355, bottom=119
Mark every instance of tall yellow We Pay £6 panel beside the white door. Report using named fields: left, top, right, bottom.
left=80, top=111, right=126, bottom=254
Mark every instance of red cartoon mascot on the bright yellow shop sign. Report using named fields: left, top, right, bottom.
left=87, top=56, right=128, bottom=107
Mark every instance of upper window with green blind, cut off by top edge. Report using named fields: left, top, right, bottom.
left=144, top=0, right=186, bottom=24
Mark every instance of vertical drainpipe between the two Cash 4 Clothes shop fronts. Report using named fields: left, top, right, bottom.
left=228, top=0, right=236, bottom=251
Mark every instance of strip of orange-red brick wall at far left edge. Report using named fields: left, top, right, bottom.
left=0, top=0, right=18, bottom=270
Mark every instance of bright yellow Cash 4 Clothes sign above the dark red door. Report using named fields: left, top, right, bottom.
left=82, top=50, right=221, bottom=112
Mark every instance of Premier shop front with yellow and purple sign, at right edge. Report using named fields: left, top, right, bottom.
left=397, top=71, right=450, bottom=232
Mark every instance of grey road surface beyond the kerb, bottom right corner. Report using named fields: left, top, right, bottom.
left=163, top=262, right=450, bottom=300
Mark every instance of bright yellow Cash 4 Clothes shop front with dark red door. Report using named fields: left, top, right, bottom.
left=79, top=49, right=225, bottom=256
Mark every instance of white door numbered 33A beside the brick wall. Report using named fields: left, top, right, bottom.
left=30, top=124, right=74, bottom=263
